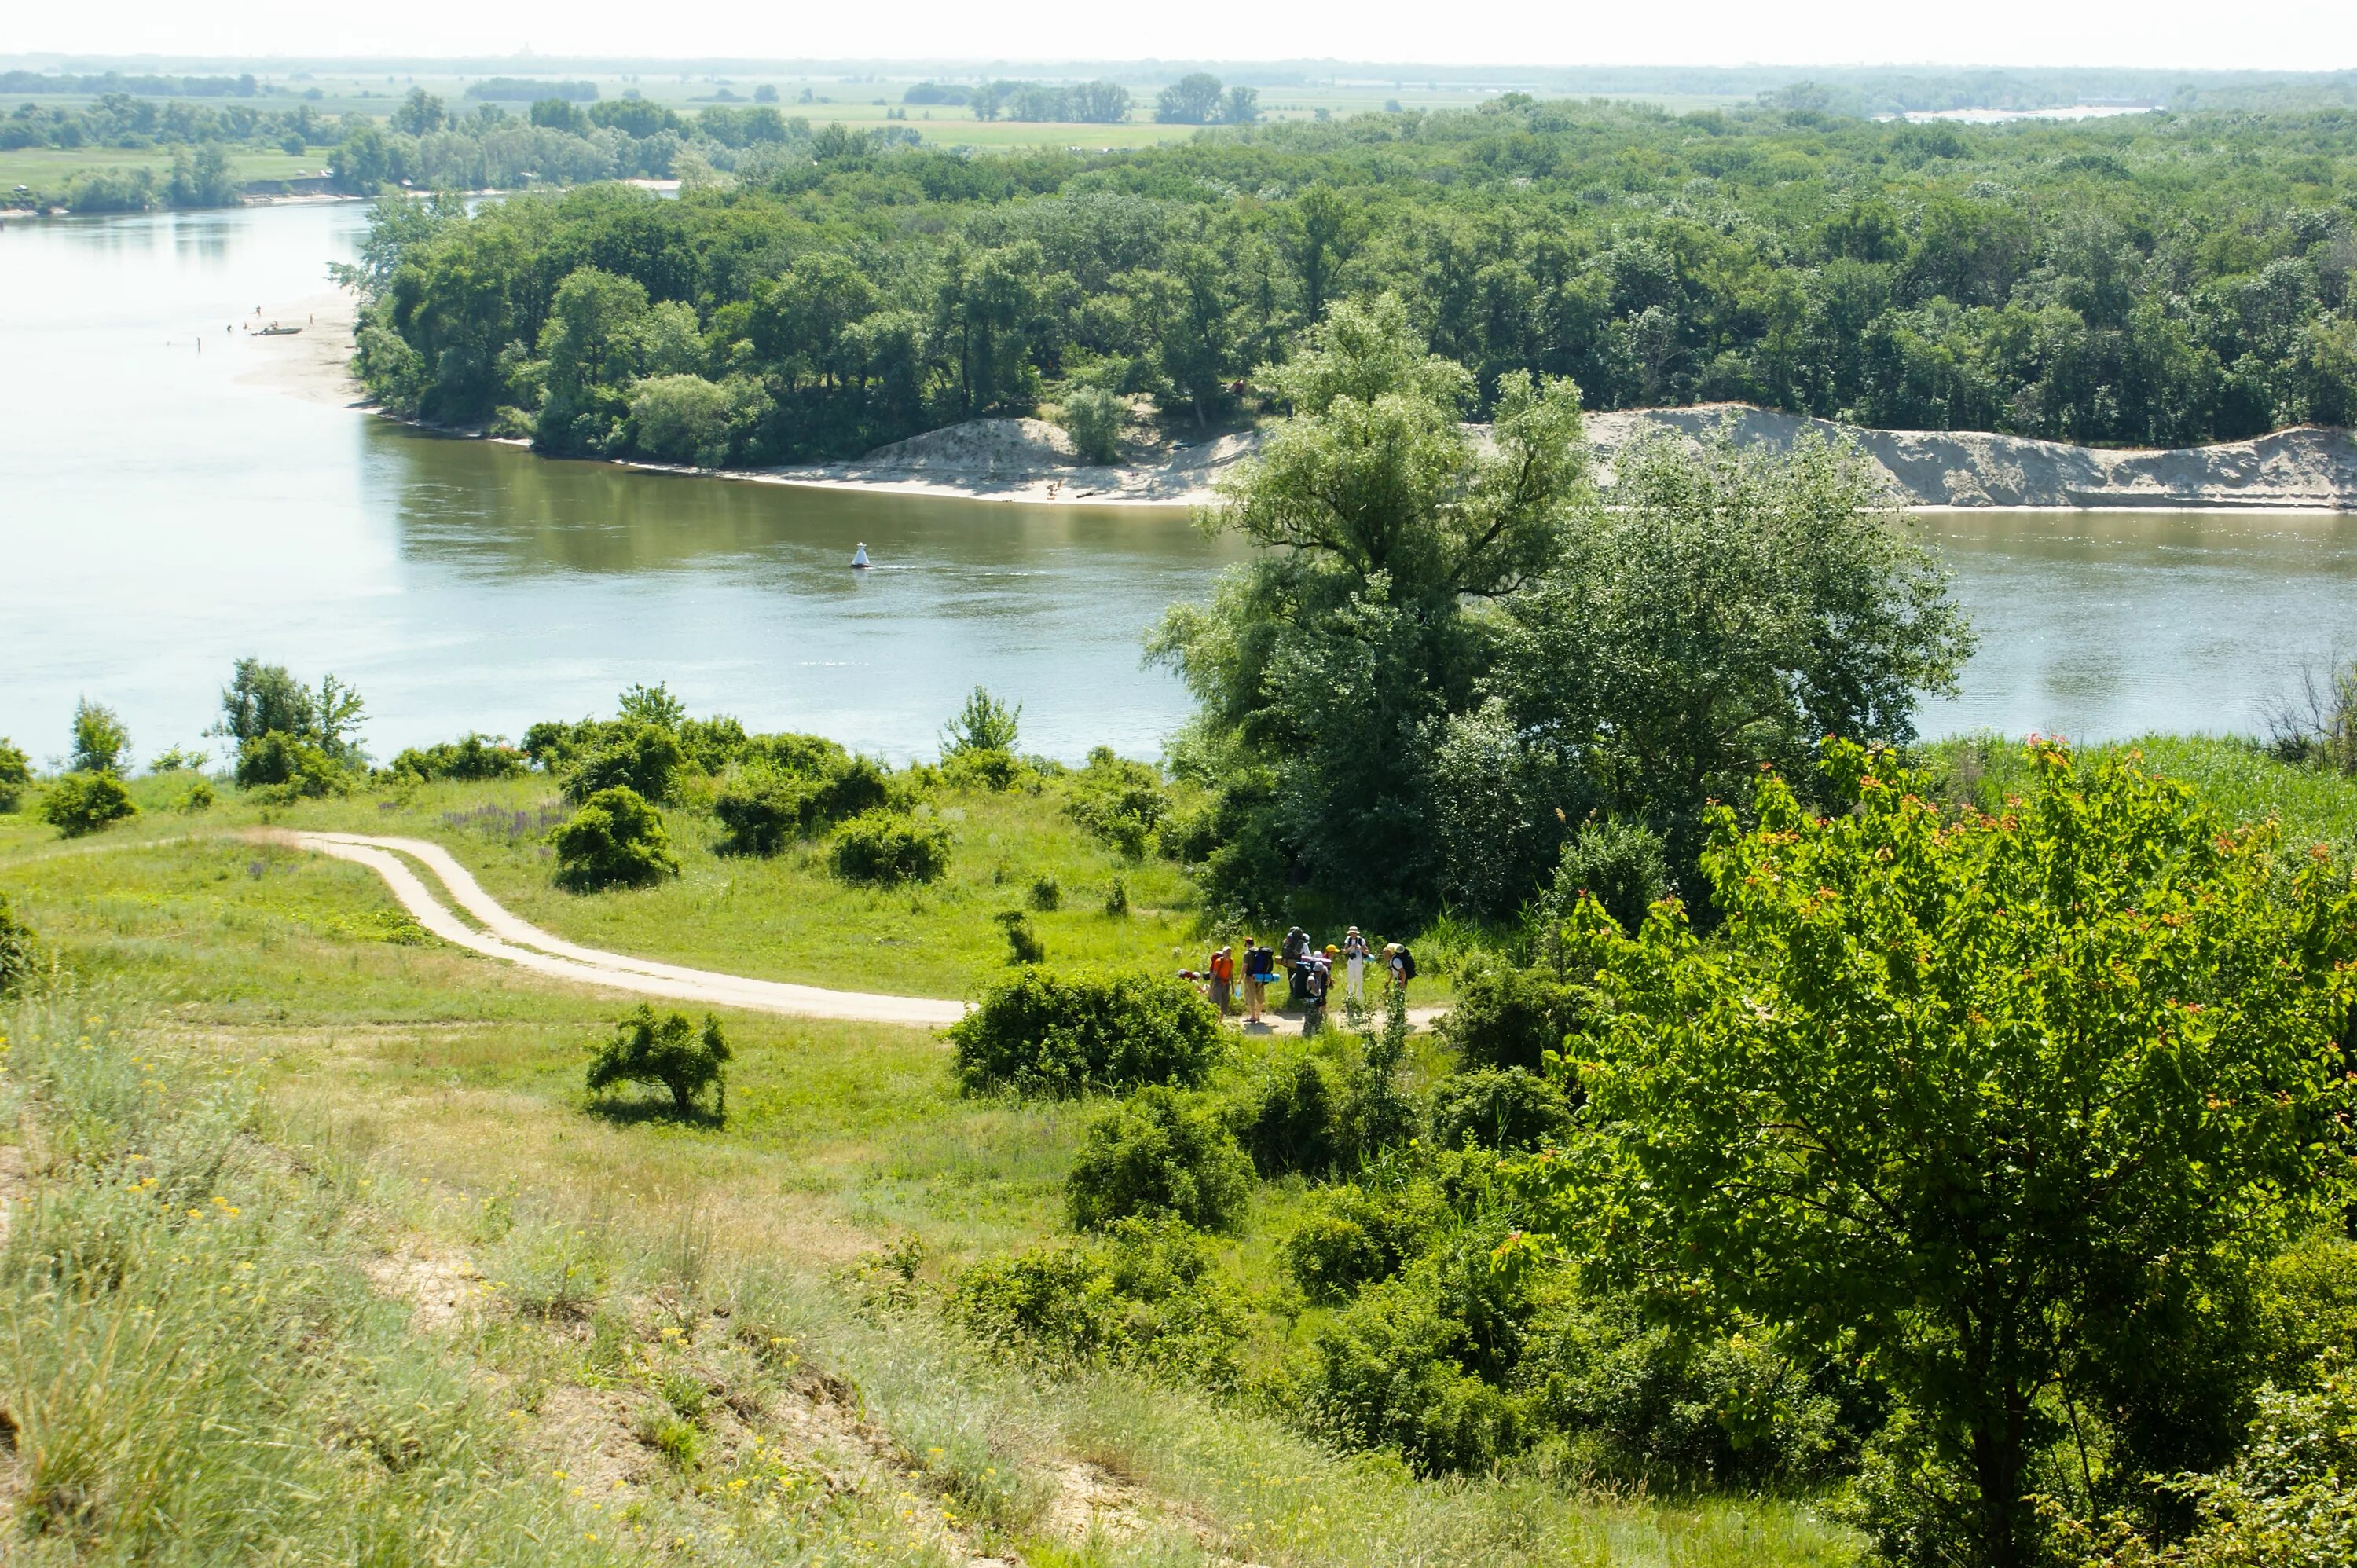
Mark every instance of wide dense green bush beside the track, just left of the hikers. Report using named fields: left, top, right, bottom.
left=950, top=969, right=1226, bottom=1099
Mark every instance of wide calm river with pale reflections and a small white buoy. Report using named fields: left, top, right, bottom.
left=0, top=203, right=2357, bottom=759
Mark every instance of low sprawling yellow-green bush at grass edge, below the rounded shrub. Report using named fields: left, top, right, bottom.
left=948, top=1219, right=1249, bottom=1384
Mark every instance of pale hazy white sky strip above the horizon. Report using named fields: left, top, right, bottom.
left=13, top=0, right=2357, bottom=71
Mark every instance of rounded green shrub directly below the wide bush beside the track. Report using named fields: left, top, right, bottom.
left=1063, top=1087, right=1252, bottom=1231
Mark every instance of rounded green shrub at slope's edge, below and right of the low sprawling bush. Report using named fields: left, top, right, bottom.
left=1303, top=1280, right=1523, bottom=1476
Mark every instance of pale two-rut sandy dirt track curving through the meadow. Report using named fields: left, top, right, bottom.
left=283, top=833, right=966, bottom=1028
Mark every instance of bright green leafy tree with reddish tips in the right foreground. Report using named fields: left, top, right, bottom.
left=1537, top=742, right=2357, bottom=1566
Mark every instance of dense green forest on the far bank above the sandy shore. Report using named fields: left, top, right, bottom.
left=339, top=94, right=2357, bottom=462
